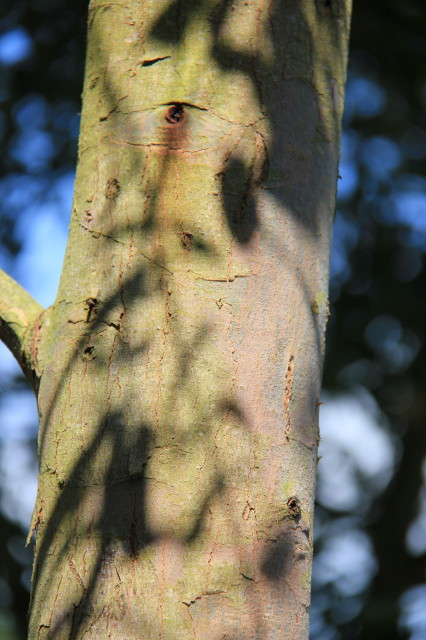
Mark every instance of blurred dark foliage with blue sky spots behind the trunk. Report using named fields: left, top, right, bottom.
left=0, top=0, right=426, bottom=640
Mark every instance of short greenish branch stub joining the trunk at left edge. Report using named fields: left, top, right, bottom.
left=0, top=269, right=43, bottom=375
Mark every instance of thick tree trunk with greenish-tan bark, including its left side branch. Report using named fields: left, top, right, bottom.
left=0, top=0, right=349, bottom=640
